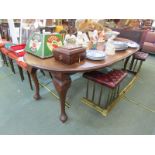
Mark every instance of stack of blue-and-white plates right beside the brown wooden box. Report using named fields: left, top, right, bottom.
left=86, top=50, right=106, bottom=60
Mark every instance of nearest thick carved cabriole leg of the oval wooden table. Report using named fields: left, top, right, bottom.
left=51, top=72, right=71, bottom=123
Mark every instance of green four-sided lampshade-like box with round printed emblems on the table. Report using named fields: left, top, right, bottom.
left=25, top=32, right=63, bottom=58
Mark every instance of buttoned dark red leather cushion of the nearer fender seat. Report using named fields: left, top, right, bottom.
left=83, top=70, right=127, bottom=88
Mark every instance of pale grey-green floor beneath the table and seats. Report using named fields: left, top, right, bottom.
left=0, top=55, right=155, bottom=135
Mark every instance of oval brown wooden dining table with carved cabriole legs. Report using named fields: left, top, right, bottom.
left=24, top=39, right=139, bottom=122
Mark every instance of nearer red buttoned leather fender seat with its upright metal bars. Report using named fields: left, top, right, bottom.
left=83, top=70, right=127, bottom=109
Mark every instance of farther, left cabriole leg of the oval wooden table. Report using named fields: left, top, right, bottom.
left=28, top=67, right=41, bottom=100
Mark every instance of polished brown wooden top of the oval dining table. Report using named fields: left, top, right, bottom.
left=24, top=38, right=139, bottom=73
